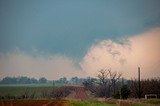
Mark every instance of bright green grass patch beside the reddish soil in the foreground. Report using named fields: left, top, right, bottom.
left=70, top=100, right=117, bottom=106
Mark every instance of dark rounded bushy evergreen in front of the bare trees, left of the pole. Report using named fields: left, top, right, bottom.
left=121, top=85, right=130, bottom=99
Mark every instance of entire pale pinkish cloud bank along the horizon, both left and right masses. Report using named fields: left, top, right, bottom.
left=0, top=28, right=160, bottom=79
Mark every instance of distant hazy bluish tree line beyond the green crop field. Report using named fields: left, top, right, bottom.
left=0, top=76, right=86, bottom=86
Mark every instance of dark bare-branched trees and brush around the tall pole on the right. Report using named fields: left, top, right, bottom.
left=83, top=69, right=160, bottom=99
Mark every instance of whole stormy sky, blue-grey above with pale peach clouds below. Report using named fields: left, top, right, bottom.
left=0, top=0, right=160, bottom=79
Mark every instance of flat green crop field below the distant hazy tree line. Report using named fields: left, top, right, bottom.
left=0, top=84, right=53, bottom=97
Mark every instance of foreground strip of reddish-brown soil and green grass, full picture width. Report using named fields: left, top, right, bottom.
left=0, top=99, right=160, bottom=106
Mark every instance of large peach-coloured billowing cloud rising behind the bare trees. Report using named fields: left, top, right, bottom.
left=81, top=28, right=160, bottom=78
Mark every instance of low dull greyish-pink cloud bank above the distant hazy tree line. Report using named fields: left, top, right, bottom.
left=0, top=50, right=85, bottom=79
